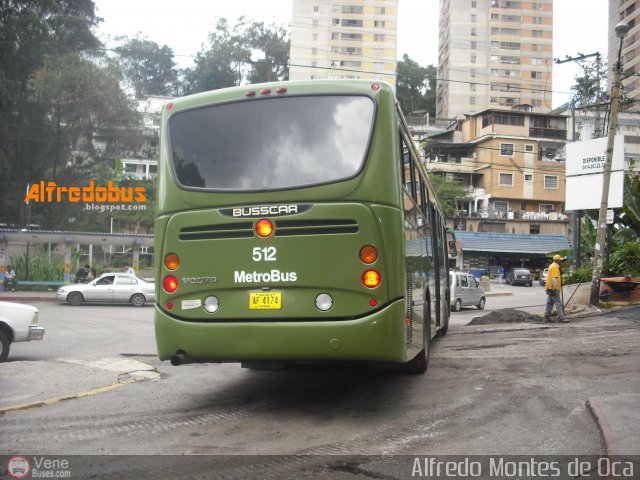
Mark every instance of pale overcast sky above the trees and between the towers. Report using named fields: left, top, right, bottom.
left=94, top=0, right=608, bottom=107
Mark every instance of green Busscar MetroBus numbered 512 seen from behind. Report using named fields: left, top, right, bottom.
left=155, top=80, right=449, bottom=373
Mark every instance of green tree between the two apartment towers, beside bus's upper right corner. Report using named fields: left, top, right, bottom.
left=396, top=53, right=436, bottom=117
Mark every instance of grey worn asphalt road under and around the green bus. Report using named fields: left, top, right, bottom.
left=0, top=294, right=640, bottom=478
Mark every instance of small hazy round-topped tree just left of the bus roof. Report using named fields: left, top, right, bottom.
left=117, top=37, right=178, bottom=99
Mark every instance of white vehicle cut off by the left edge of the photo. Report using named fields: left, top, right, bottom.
left=0, top=302, right=44, bottom=362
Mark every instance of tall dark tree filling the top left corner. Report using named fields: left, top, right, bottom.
left=0, top=0, right=100, bottom=225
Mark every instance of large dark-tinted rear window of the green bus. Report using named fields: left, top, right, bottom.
left=169, top=95, right=375, bottom=191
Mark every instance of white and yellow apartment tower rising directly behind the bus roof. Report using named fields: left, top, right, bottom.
left=289, top=0, right=398, bottom=85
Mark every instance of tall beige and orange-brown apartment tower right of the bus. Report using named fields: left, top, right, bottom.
left=436, top=0, right=553, bottom=119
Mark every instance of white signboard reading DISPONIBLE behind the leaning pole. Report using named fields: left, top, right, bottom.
left=565, top=135, right=624, bottom=210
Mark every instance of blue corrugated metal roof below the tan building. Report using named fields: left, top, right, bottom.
left=456, top=231, right=570, bottom=254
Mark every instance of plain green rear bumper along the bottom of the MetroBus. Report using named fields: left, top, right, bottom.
left=155, top=300, right=407, bottom=365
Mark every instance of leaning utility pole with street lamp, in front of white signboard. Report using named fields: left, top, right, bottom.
left=589, top=22, right=629, bottom=305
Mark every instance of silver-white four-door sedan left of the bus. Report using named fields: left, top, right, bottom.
left=57, top=273, right=156, bottom=307
